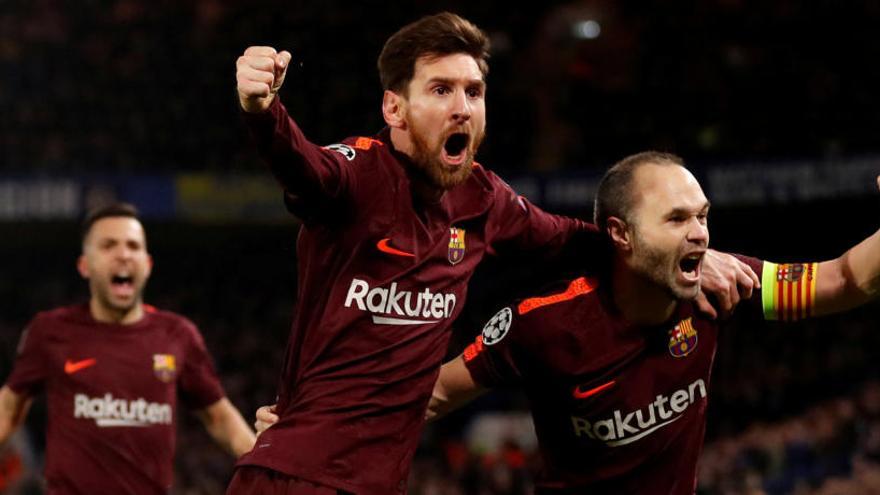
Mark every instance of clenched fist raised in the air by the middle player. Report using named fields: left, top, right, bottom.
left=235, top=46, right=291, bottom=113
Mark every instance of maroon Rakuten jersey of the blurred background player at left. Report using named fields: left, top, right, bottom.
left=6, top=304, right=223, bottom=494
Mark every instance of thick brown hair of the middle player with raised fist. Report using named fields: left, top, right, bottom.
left=377, top=12, right=489, bottom=94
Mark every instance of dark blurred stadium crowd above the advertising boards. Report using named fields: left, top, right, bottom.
left=0, top=0, right=880, bottom=173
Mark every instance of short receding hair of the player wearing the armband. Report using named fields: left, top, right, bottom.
left=593, top=151, right=684, bottom=233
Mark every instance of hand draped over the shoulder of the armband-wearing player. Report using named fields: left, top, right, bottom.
left=696, top=249, right=761, bottom=319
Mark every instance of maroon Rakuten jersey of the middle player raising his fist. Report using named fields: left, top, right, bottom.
left=239, top=98, right=592, bottom=495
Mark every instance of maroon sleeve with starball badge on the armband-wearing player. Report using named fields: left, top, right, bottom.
left=462, top=306, right=523, bottom=387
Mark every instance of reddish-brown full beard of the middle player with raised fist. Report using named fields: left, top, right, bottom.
left=406, top=117, right=486, bottom=190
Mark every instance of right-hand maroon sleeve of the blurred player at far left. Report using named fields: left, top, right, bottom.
left=178, top=321, right=225, bottom=409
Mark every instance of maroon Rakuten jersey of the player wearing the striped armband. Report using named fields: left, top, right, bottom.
left=463, top=258, right=772, bottom=495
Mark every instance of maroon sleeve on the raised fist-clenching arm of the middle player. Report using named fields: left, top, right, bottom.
left=242, top=96, right=356, bottom=214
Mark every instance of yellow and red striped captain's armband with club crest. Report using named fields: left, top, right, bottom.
left=761, top=261, right=819, bottom=321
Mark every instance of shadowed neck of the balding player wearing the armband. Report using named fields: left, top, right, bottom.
left=611, top=256, right=678, bottom=325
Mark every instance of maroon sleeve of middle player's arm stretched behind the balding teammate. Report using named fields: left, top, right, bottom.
left=486, top=171, right=601, bottom=259
